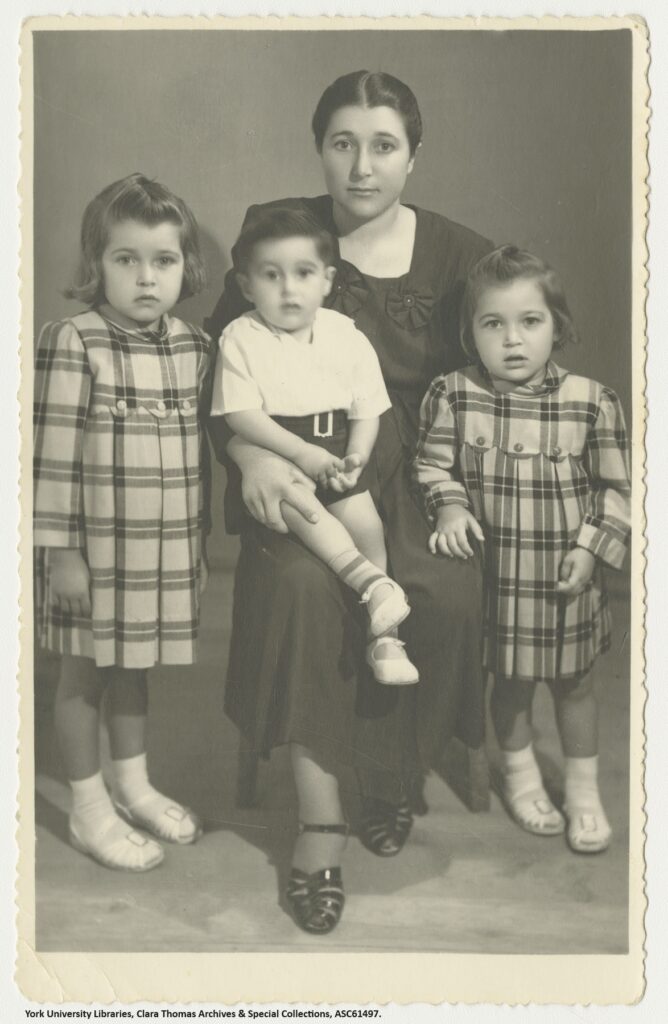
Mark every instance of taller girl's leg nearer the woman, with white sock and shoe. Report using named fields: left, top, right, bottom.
left=105, top=667, right=202, bottom=844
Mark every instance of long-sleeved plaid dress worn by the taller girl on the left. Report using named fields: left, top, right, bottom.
left=34, top=310, right=210, bottom=669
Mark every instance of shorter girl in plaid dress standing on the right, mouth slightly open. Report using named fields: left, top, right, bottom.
left=415, top=246, right=630, bottom=853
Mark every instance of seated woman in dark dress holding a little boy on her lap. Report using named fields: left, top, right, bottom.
left=207, top=71, right=492, bottom=932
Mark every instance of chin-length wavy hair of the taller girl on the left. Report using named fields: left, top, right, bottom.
left=65, top=173, right=206, bottom=305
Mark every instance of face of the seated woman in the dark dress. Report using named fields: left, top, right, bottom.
left=322, top=106, right=415, bottom=221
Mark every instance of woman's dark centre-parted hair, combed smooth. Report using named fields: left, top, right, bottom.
left=311, top=71, right=422, bottom=157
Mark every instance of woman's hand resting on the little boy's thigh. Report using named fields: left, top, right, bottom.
left=240, top=445, right=320, bottom=534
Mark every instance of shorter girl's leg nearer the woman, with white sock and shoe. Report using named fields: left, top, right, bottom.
left=491, top=679, right=565, bottom=836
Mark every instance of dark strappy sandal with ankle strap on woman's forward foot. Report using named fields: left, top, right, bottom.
left=286, top=823, right=349, bottom=935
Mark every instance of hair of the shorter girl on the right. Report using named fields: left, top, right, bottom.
left=460, top=245, right=578, bottom=362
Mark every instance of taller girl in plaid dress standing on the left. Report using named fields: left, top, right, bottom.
left=34, top=174, right=210, bottom=871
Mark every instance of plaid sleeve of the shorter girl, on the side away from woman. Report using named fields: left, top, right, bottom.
left=576, top=388, right=631, bottom=568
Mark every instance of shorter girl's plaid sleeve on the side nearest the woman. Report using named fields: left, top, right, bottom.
left=413, top=378, right=470, bottom=520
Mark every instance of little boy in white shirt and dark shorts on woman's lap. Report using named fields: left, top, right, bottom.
left=211, top=208, right=418, bottom=684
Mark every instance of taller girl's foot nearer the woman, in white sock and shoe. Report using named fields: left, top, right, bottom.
left=112, top=753, right=201, bottom=843
